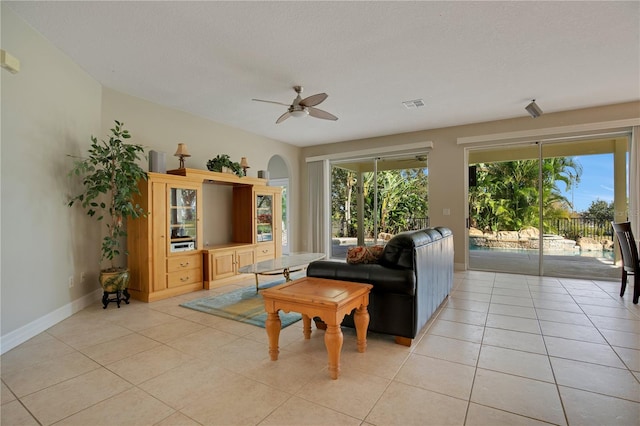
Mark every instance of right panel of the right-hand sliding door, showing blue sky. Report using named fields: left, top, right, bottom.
left=541, top=137, right=627, bottom=279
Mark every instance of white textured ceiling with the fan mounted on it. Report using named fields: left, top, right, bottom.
left=6, top=1, right=640, bottom=146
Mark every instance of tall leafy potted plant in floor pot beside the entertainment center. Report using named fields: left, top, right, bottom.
left=68, top=120, right=147, bottom=308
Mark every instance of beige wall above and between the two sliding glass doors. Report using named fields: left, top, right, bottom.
left=301, top=102, right=640, bottom=268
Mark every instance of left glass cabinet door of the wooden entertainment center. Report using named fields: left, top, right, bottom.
left=168, top=186, right=199, bottom=252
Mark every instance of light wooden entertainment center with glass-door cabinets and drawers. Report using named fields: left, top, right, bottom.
left=127, top=169, right=282, bottom=302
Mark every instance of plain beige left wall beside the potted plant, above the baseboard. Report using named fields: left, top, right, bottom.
left=0, top=4, right=101, bottom=342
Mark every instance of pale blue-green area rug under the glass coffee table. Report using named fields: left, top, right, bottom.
left=180, top=279, right=302, bottom=328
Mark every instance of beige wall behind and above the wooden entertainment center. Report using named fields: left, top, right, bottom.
left=102, top=88, right=301, bottom=250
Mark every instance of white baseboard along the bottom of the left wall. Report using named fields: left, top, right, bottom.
left=0, top=288, right=103, bottom=354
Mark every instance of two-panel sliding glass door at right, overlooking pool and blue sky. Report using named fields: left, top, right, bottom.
left=468, top=137, right=627, bottom=278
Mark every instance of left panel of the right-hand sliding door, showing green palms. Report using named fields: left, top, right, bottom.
left=469, top=144, right=540, bottom=275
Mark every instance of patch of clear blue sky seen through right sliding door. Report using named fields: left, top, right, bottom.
left=558, top=154, right=613, bottom=212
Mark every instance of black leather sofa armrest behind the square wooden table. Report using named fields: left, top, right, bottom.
left=307, top=260, right=416, bottom=296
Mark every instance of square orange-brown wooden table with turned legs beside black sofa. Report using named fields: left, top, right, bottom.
left=262, top=277, right=373, bottom=379
